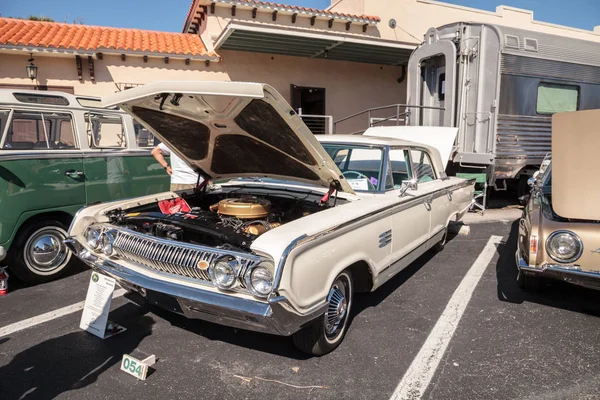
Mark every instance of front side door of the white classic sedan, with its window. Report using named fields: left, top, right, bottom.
left=386, top=148, right=431, bottom=282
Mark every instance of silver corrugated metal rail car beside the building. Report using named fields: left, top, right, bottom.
left=406, top=23, right=600, bottom=195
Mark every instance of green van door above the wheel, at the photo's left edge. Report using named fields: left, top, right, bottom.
left=0, top=109, right=85, bottom=244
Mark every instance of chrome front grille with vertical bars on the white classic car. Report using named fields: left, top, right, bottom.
left=111, top=229, right=259, bottom=287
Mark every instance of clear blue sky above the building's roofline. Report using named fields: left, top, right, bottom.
left=0, top=0, right=600, bottom=32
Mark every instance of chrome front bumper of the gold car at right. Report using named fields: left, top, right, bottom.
left=515, top=249, right=600, bottom=290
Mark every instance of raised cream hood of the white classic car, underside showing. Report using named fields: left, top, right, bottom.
left=102, top=81, right=354, bottom=193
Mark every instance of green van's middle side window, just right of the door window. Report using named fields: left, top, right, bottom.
left=85, top=113, right=127, bottom=149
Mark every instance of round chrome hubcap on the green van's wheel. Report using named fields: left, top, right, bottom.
left=25, top=228, right=68, bottom=272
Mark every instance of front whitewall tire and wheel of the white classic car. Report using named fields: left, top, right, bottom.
left=294, top=271, right=353, bottom=356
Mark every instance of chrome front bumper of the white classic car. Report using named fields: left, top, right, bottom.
left=65, top=238, right=327, bottom=336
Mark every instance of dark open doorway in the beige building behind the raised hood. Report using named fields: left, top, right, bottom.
left=290, top=85, right=329, bottom=134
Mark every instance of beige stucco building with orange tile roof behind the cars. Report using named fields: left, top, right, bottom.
left=0, top=0, right=600, bottom=132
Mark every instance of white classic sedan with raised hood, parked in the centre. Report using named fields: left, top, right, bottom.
left=66, top=82, right=474, bottom=355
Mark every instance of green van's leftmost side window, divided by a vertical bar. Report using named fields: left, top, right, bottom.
left=3, top=111, right=77, bottom=150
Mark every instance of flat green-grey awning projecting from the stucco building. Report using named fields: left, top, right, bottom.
left=215, top=22, right=415, bottom=65
